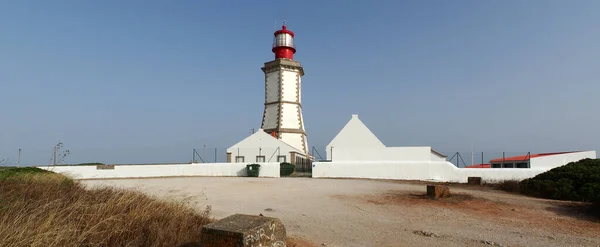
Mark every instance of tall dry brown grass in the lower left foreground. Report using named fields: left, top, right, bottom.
left=0, top=169, right=211, bottom=246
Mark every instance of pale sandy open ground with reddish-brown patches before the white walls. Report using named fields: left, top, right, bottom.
left=83, top=177, right=600, bottom=247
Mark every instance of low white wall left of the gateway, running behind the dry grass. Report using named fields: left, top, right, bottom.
left=39, top=162, right=279, bottom=179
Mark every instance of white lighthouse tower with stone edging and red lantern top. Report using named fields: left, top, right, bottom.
left=262, top=23, right=308, bottom=155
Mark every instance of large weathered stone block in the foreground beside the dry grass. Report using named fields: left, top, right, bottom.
left=200, top=214, right=286, bottom=247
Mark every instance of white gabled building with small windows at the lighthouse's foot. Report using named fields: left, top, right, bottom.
left=227, top=129, right=308, bottom=164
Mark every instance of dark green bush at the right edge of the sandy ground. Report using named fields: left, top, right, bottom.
left=520, top=159, right=600, bottom=204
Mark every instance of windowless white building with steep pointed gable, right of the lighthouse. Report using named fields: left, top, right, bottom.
left=325, top=115, right=447, bottom=162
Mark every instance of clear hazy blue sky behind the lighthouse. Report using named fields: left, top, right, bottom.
left=0, top=0, right=600, bottom=164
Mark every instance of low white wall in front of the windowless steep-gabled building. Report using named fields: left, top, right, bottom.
left=312, top=161, right=547, bottom=183
